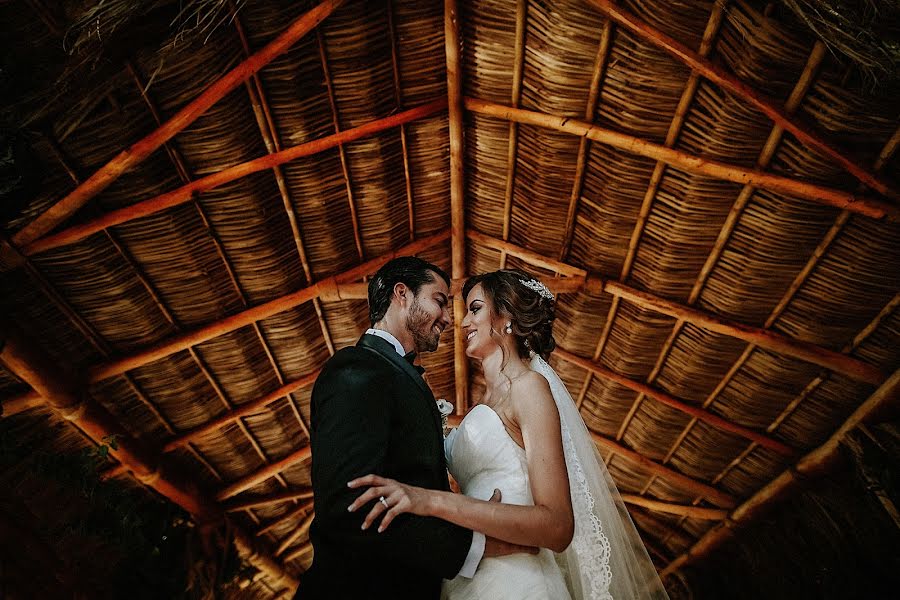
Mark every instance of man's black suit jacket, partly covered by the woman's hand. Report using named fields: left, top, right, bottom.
left=295, top=334, right=472, bottom=600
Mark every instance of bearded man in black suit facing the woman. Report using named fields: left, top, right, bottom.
left=295, top=256, right=527, bottom=600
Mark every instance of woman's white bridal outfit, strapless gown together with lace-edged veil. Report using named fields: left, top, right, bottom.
left=441, top=356, right=668, bottom=600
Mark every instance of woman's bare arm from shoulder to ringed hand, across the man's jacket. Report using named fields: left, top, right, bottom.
left=348, top=373, right=575, bottom=552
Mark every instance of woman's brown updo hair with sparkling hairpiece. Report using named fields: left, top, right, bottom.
left=463, top=269, right=556, bottom=360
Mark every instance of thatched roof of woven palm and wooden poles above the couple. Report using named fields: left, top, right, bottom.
left=0, top=0, right=900, bottom=597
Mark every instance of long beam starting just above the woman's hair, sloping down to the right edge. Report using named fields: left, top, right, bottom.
left=467, top=230, right=887, bottom=385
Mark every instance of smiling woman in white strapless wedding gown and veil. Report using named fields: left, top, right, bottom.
left=348, top=270, right=668, bottom=600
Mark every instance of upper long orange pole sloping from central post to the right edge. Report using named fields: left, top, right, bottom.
left=465, top=98, right=900, bottom=222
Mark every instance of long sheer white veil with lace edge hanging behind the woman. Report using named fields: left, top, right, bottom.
left=531, top=355, right=668, bottom=600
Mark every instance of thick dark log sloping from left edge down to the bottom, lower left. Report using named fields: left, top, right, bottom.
left=0, top=322, right=297, bottom=587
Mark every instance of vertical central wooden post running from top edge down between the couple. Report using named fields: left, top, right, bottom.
left=444, top=0, right=469, bottom=414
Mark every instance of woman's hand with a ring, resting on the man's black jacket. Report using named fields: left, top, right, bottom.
left=347, top=475, right=431, bottom=533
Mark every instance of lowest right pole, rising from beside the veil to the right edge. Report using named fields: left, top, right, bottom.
left=660, top=369, right=900, bottom=577
